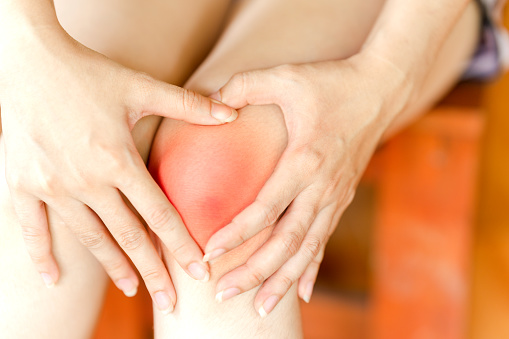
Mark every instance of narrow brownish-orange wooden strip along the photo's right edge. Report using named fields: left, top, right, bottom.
left=471, top=42, right=509, bottom=339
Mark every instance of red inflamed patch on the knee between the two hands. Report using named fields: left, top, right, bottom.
left=149, top=113, right=283, bottom=248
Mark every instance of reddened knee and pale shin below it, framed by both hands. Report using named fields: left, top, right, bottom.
left=149, top=106, right=299, bottom=338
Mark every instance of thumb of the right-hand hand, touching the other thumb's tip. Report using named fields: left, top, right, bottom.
left=210, top=68, right=284, bottom=109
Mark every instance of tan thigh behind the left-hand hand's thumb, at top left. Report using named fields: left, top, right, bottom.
left=54, top=0, right=230, bottom=160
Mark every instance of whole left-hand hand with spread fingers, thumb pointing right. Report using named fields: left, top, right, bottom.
left=0, top=27, right=237, bottom=310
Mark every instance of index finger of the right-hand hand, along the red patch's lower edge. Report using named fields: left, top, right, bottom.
left=203, top=151, right=307, bottom=261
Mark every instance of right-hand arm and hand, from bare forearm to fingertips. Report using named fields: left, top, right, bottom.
left=200, top=0, right=479, bottom=316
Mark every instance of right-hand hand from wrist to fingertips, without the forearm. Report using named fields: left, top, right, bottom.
left=204, top=54, right=409, bottom=316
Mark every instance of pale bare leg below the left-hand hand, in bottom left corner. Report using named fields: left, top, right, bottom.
left=0, top=138, right=110, bottom=339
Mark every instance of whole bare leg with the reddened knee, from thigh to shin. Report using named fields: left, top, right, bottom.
left=150, top=0, right=478, bottom=338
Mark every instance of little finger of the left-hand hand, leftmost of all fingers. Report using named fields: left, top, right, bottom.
left=11, top=192, right=59, bottom=288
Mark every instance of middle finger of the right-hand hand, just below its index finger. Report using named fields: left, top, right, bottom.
left=211, top=191, right=316, bottom=301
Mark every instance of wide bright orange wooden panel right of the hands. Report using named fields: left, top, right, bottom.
left=370, top=106, right=483, bottom=339
